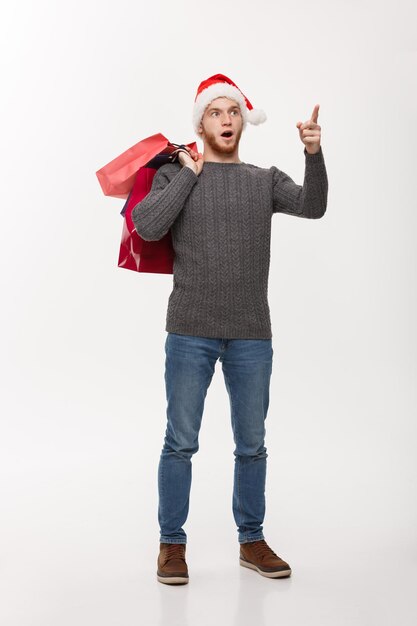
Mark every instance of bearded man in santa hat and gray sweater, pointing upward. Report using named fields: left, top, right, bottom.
left=132, top=74, right=328, bottom=584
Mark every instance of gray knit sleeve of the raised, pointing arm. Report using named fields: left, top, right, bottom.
left=270, top=146, right=328, bottom=219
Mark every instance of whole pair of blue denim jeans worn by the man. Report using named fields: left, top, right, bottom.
left=158, top=333, right=273, bottom=543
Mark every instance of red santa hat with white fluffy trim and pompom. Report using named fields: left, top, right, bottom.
left=193, top=74, right=266, bottom=135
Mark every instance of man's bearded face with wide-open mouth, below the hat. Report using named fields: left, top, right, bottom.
left=200, top=97, right=243, bottom=154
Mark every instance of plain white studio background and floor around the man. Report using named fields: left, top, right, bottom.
left=0, top=0, right=417, bottom=626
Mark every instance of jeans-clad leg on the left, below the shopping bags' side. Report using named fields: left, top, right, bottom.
left=158, top=333, right=220, bottom=543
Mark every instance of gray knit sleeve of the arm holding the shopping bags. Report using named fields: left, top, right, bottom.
left=132, top=166, right=198, bottom=241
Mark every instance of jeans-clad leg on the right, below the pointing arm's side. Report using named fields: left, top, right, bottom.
left=220, top=339, right=273, bottom=543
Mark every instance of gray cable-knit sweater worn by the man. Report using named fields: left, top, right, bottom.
left=132, top=148, right=328, bottom=339
